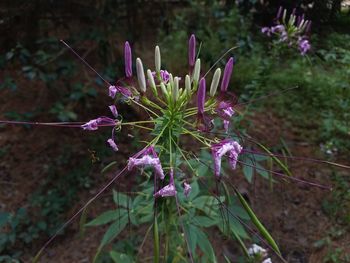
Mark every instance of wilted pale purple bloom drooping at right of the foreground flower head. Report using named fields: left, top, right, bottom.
left=211, top=139, right=242, bottom=177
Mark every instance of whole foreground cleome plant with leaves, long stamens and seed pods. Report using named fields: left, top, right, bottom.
left=2, top=35, right=348, bottom=263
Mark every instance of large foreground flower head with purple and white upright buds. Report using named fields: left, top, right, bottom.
left=81, top=35, right=242, bottom=197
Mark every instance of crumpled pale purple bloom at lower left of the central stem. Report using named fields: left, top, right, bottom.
left=128, top=146, right=165, bottom=180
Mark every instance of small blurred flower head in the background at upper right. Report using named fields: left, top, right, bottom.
left=261, top=7, right=312, bottom=56
